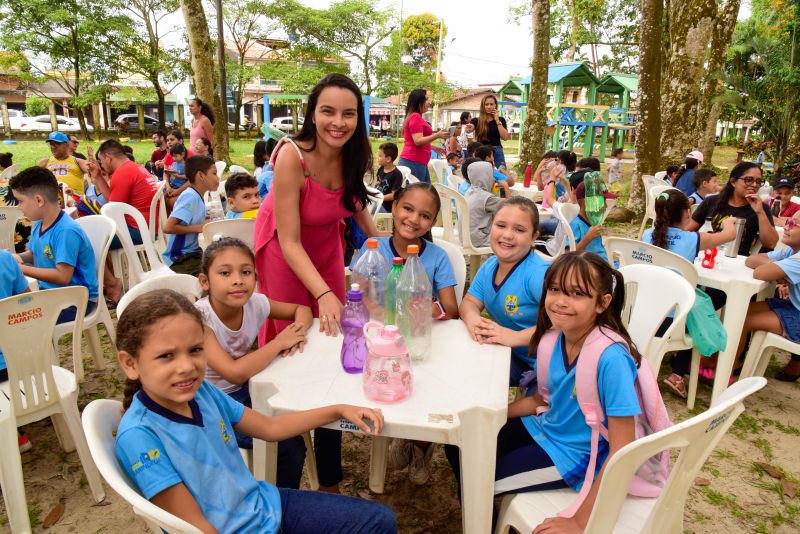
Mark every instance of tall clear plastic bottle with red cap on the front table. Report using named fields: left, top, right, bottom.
left=397, top=245, right=433, bottom=361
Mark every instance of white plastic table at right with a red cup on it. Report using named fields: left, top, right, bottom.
left=689, top=258, right=774, bottom=409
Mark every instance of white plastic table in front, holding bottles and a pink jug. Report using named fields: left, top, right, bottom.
left=250, top=319, right=511, bottom=534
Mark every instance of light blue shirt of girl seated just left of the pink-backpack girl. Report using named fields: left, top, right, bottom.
left=468, top=251, right=549, bottom=368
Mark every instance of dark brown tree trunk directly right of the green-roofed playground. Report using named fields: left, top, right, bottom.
left=627, top=0, right=664, bottom=218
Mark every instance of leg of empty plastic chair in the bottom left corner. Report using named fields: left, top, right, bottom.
left=0, top=417, right=31, bottom=533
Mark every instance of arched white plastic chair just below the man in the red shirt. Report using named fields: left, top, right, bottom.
left=100, top=202, right=173, bottom=287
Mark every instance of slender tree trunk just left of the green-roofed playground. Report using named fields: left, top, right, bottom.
left=519, top=0, right=550, bottom=170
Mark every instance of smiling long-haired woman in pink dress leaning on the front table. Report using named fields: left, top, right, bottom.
left=255, top=74, right=377, bottom=491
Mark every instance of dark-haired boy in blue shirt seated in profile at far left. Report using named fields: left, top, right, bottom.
left=8, top=167, right=98, bottom=323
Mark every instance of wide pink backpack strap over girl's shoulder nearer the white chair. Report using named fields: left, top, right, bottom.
left=558, top=327, right=627, bottom=517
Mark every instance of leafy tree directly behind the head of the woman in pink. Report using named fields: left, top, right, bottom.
left=269, top=0, right=394, bottom=94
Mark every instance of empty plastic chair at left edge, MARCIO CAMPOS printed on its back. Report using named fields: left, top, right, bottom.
left=0, top=286, right=105, bottom=532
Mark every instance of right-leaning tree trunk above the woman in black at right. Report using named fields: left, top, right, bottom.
left=697, top=0, right=739, bottom=165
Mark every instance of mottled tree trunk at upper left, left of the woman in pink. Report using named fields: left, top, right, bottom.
left=181, top=0, right=229, bottom=161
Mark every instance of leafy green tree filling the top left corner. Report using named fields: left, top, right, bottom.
left=0, top=0, right=130, bottom=137
